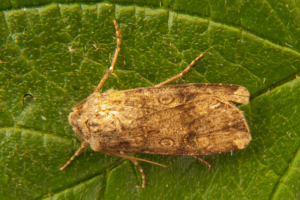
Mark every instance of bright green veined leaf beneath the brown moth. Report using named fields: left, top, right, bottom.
left=0, top=0, right=300, bottom=199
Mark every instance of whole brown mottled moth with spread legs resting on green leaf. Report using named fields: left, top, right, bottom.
left=60, top=20, right=251, bottom=188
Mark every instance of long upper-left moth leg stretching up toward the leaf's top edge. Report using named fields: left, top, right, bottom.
left=94, top=20, right=121, bottom=92
